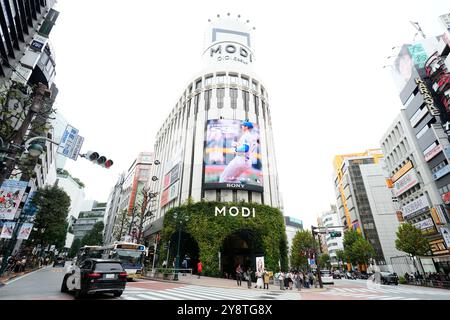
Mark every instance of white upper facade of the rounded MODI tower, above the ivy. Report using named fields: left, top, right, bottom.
left=146, top=16, right=281, bottom=233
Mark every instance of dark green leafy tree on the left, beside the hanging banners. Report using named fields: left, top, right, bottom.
left=30, top=185, right=70, bottom=250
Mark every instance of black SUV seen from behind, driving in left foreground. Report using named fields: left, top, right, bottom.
left=61, top=258, right=127, bottom=298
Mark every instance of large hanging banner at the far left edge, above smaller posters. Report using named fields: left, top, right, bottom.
left=0, top=180, right=28, bottom=220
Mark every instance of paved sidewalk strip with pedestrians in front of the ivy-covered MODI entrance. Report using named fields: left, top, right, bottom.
left=141, top=274, right=327, bottom=293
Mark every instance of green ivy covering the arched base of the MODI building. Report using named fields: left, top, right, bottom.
left=160, top=199, right=288, bottom=276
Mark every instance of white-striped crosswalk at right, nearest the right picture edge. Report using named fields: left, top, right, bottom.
left=321, top=286, right=450, bottom=300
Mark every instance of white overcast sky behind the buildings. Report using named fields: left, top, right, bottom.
left=50, top=0, right=450, bottom=228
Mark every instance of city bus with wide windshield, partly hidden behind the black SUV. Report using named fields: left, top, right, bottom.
left=101, top=242, right=146, bottom=279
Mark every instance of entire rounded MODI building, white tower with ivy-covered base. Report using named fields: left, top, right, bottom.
left=144, top=14, right=287, bottom=276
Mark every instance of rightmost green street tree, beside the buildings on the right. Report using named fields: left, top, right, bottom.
left=395, top=223, right=430, bottom=256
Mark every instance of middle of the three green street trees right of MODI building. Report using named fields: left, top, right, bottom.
left=343, top=230, right=375, bottom=265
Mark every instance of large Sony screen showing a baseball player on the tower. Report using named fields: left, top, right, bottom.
left=204, top=119, right=263, bottom=192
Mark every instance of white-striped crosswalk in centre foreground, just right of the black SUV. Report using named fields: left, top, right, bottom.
left=120, top=285, right=300, bottom=300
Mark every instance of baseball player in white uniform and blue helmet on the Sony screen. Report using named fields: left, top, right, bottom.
left=219, top=121, right=257, bottom=182
